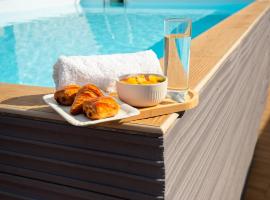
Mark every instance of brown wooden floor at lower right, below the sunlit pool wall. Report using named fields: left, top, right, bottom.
left=242, top=90, right=270, bottom=200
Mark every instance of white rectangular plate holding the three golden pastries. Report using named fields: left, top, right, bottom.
left=43, top=94, right=140, bottom=126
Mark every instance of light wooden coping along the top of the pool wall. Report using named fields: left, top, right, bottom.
left=0, top=1, right=270, bottom=134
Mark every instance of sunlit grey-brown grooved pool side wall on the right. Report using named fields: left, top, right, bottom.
left=164, top=4, right=270, bottom=200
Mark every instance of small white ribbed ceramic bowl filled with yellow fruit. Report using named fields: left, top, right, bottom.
left=116, top=74, right=168, bottom=107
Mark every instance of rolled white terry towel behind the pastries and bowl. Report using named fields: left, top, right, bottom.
left=53, top=50, right=162, bottom=92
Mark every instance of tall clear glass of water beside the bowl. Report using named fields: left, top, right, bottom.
left=164, top=18, right=192, bottom=95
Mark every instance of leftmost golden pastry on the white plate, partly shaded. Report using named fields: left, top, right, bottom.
left=54, top=85, right=81, bottom=106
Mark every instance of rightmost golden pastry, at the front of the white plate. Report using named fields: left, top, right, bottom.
left=83, top=96, right=120, bottom=120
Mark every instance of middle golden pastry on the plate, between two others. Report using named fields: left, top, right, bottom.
left=70, top=84, right=103, bottom=115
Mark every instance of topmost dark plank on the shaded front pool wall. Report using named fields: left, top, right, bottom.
left=0, top=115, right=163, bottom=162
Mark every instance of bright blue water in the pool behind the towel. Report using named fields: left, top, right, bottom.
left=0, top=0, right=253, bottom=86
